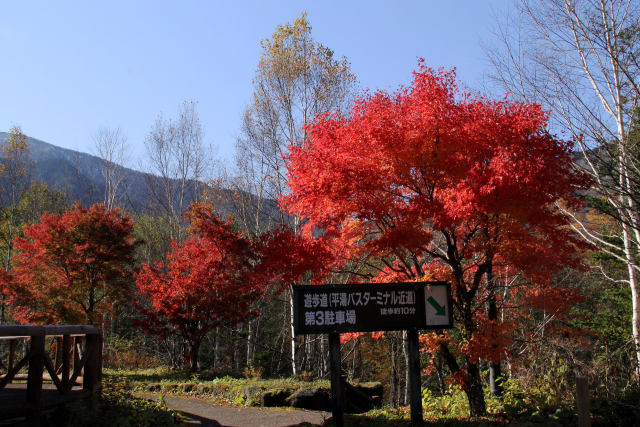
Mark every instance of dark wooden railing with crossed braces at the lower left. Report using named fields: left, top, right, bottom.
left=0, top=325, right=102, bottom=420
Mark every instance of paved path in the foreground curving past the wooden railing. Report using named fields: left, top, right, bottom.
left=140, top=393, right=331, bottom=427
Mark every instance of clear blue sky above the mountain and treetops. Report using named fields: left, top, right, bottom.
left=0, top=0, right=509, bottom=171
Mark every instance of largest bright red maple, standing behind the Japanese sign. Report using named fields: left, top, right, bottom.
left=282, top=63, right=586, bottom=415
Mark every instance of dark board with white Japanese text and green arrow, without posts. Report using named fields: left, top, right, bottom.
left=293, top=282, right=453, bottom=335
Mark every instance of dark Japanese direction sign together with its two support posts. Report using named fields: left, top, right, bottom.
left=293, top=282, right=453, bottom=426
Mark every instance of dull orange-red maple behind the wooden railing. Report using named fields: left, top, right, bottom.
left=0, top=204, right=137, bottom=324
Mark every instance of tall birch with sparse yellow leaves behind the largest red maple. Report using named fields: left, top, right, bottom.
left=234, top=13, right=356, bottom=375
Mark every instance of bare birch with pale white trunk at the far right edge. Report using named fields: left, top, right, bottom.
left=488, top=0, right=640, bottom=372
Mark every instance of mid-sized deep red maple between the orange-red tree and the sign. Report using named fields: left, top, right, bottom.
left=136, top=204, right=322, bottom=372
